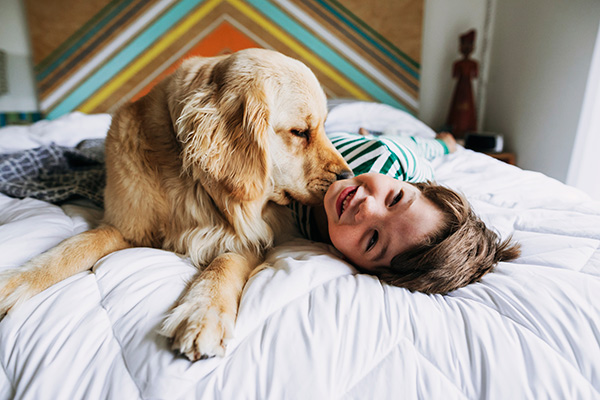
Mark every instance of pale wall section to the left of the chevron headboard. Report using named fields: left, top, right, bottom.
left=0, top=0, right=38, bottom=112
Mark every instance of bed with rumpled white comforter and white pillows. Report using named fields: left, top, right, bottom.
left=0, top=103, right=600, bottom=399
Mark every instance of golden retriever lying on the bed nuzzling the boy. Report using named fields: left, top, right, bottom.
left=0, top=49, right=351, bottom=360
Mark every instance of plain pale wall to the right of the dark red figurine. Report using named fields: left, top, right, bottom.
left=484, top=0, right=600, bottom=182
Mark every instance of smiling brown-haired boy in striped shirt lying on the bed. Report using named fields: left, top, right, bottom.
left=293, top=129, right=520, bottom=293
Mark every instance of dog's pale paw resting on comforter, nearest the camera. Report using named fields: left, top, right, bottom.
left=160, top=284, right=236, bottom=361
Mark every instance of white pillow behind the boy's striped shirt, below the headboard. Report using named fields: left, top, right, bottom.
left=325, top=100, right=435, bottom=138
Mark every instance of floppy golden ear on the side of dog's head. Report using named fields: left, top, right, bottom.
left=177, top=84, right=269, bottom=201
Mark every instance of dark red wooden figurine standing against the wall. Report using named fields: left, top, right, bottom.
left=447, top=29, right=479, bottom=139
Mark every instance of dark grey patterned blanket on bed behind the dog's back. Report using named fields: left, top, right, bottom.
left=0, top=139, right=105, bottom=207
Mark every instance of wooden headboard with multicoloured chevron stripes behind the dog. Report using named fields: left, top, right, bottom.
left=26, top=0, right=423, bottom=118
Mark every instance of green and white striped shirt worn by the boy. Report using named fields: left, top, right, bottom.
left=290, top=132, right=448, bottom=240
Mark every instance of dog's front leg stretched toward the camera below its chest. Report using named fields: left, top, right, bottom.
left=161, top=253, right=259, bottom=361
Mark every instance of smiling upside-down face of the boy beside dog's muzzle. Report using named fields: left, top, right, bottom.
left=324, top=173, right=442, bottom=269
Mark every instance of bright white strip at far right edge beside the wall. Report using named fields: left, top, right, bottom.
left=567, top=21, right=600, bottom=200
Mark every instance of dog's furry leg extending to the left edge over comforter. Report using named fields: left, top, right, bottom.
left=0, top=225, right=131, bottom=318
